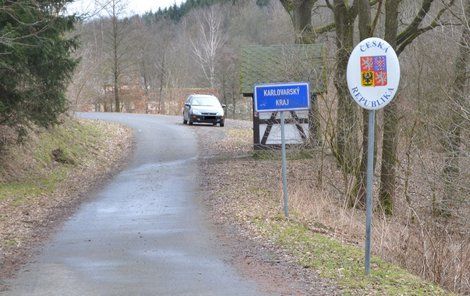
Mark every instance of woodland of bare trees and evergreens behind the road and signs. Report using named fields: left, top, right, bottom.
left=0, top=0, right=470, bottom=294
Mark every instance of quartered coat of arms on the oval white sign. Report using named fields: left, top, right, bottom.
left=361, top=56, right=387, bottom=86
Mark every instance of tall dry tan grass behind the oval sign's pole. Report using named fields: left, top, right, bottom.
left=290, top=177, right=470, bottom=294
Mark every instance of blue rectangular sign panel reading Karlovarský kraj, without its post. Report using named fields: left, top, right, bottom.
left=253, top=82, right=310, bottom=112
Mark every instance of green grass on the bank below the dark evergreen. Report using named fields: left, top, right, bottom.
left=0, top=119, right=105, bottom=206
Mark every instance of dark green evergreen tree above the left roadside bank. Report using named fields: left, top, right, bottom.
left=0, top=0, right=77, bottom=138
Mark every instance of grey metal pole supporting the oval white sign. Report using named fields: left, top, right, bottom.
left=365, top=110, right=375, bottom=275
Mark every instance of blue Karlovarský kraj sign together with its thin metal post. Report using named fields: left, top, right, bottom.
left=253, top=82, right=310, bottom=218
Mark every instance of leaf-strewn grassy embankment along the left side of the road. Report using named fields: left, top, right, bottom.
left=0, top=118, right=132, bottom=287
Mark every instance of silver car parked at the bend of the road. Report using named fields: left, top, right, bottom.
left=183, top=95, right=225, bottom=126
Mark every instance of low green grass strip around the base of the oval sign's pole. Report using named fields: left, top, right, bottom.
left=254, top=219, right=451, bottom=295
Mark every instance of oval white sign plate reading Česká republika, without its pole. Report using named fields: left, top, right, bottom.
left=346, top=37, right=400, bottom=110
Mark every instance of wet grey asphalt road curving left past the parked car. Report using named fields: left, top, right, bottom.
left=4, top=113, right=264, bottom=296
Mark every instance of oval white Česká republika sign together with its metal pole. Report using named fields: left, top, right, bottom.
left=347, top=37, right=400, bottom=275
